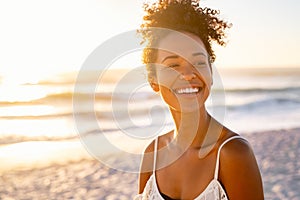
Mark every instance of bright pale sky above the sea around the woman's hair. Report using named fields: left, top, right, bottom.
left=0, top=0, right=300, bottom=81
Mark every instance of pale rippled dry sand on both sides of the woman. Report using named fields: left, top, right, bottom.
left=0, top=128, right=300, bottom=200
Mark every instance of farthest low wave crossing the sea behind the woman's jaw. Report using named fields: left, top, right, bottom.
left=0, top=83, right=300, bottom=106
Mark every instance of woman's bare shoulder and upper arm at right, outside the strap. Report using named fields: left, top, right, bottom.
left=219, top=139, right=264, bottom=200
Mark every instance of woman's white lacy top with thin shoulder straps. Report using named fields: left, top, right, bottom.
left=134, top=136, right=243, bottom=200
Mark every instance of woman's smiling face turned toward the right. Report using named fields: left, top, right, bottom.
left=152, top=31, right=212, bottom=112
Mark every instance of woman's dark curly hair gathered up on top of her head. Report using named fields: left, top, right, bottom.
left=138, top=0, right=231, bottom=80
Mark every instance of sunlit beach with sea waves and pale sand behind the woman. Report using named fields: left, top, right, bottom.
left=0, top=68, right=300, bottom=200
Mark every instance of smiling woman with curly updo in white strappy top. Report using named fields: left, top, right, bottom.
left=136, top=0, right=264, bottom=200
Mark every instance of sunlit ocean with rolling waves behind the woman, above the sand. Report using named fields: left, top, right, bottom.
left=0, top=68, right=300, bottom=171
